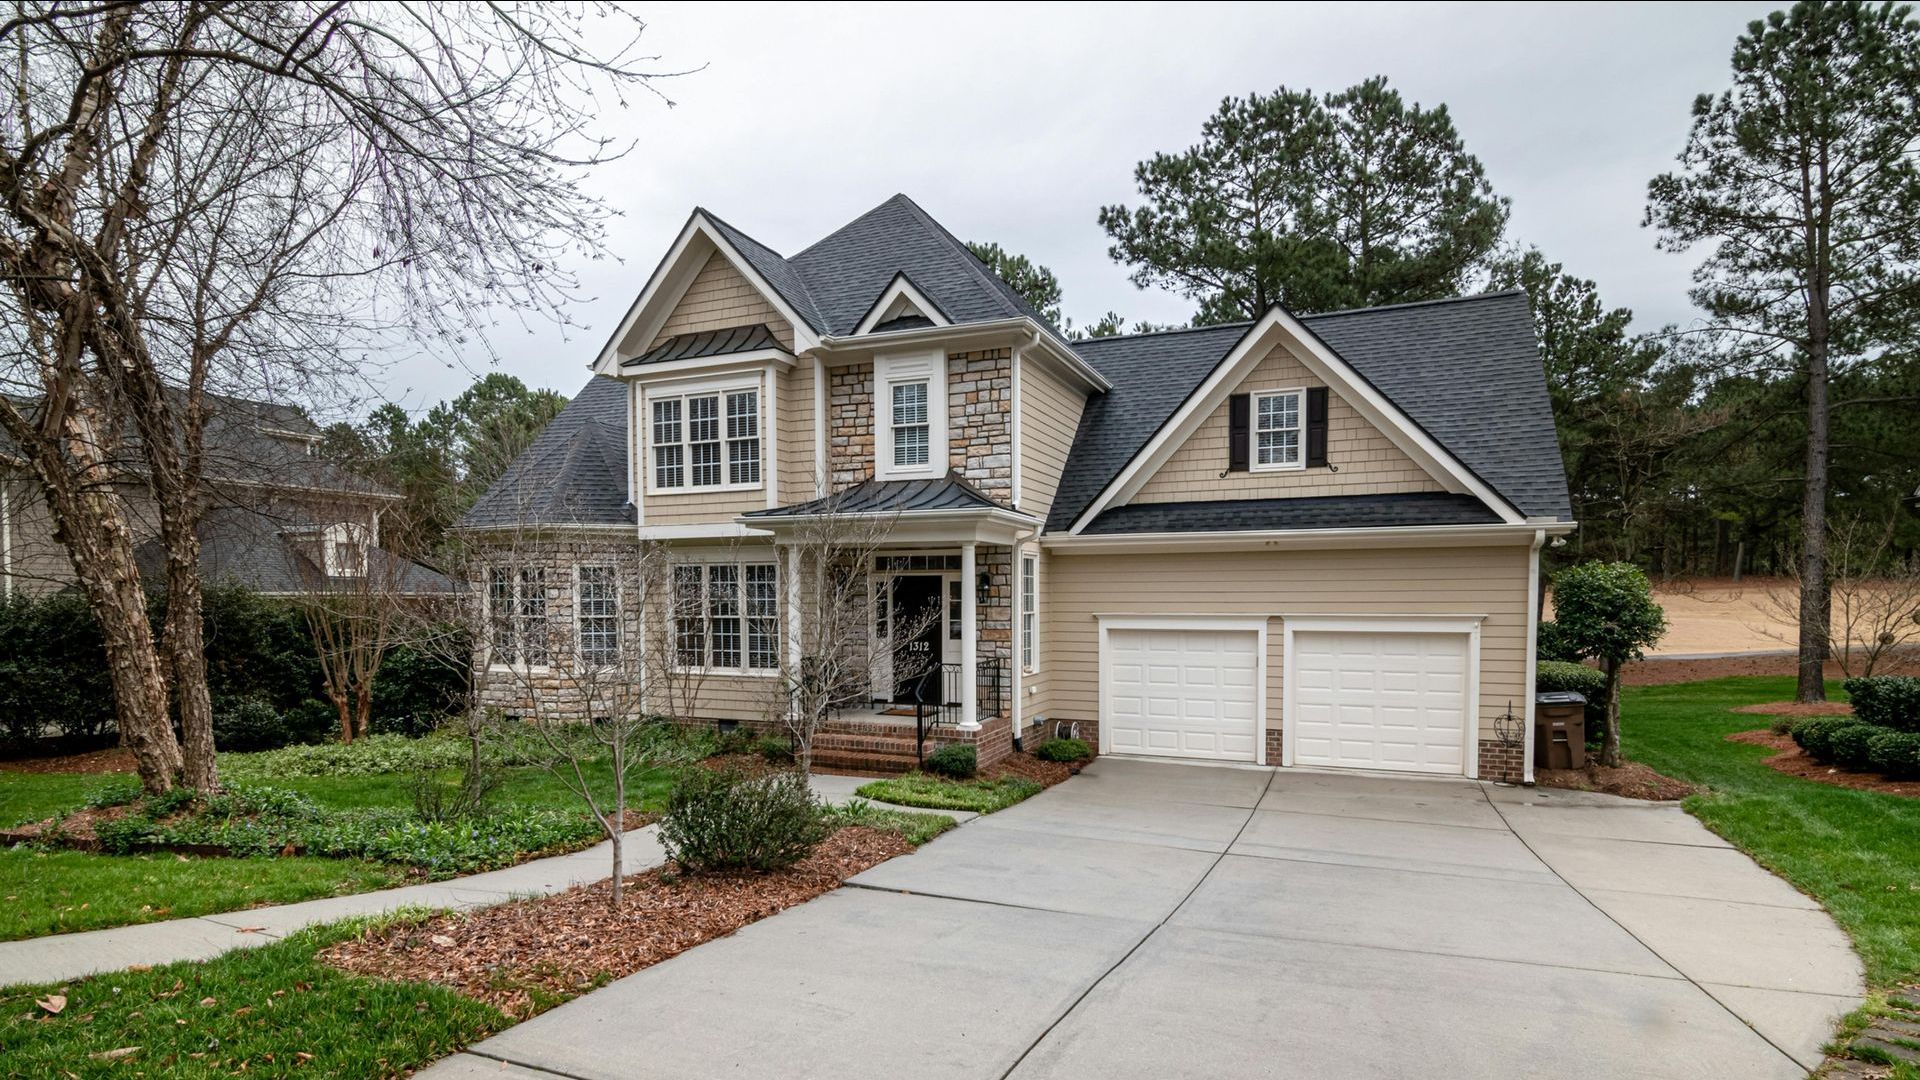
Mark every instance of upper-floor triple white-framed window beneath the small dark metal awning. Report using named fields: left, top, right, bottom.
left=649, top=388, right=760, bottom=492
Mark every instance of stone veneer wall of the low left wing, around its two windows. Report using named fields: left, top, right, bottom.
left=467, top=540, right=641, bottom=721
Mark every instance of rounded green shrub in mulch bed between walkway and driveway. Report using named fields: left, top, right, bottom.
left=660, top=769, right=833, bottom=872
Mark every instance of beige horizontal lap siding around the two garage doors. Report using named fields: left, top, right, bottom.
left=1041, top=546, right=1530, bottom=738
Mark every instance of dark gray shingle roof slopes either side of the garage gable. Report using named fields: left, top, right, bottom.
left=1048, top=290, right=1572, bottom=530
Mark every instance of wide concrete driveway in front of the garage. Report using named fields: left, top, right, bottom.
left=428, top=759, right=1862, bottom=1080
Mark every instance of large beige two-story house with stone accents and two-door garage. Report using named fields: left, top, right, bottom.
left=463, top=196, right=1574, bottom=778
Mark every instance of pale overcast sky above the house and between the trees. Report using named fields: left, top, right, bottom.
left=388, top=2, right=1772, bottom=409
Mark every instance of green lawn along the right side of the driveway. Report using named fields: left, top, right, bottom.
left=1620, top=678, right=1920, bottom=990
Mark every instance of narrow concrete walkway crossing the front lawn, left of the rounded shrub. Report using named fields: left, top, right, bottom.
left=0, top=824, right=666, bottom=986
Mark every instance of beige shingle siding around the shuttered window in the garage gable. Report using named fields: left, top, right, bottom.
left=1133, top=346, right=1446, bottom=503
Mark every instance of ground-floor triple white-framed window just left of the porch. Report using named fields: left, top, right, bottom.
left=672, top=563, right=780, bottom=673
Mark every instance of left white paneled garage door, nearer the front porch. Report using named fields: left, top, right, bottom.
left=1100, top=628, right=1260, bottom=761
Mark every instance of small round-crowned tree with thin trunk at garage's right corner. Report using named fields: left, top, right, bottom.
left=1553, top=563, right=1667, bottom=769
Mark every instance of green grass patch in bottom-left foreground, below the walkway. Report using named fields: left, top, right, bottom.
left=0, top=910, right=509, bottom=1078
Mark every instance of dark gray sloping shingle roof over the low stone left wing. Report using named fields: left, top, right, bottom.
left=459, top=377, right=634, bottom=528
